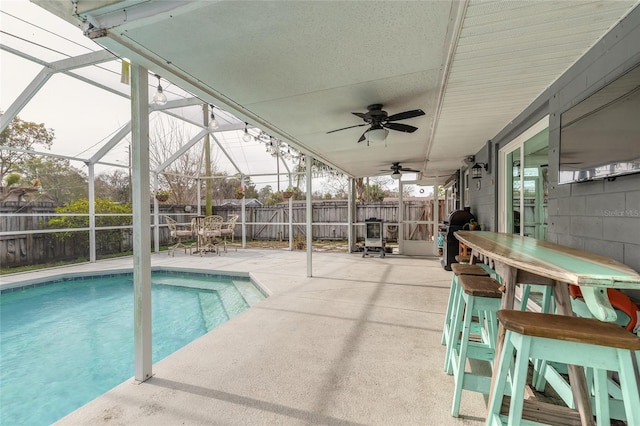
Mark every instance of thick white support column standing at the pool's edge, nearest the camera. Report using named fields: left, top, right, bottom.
left=131, top=63, right=152, bottom=382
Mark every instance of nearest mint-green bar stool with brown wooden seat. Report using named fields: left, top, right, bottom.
left=486, top=310, right=640, bottom=426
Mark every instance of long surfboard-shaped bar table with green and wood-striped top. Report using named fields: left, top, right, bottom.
left=455, top=231, right=640, bottom=425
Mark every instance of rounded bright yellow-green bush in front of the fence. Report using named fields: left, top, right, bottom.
left=48, top=198, right=132, bottom=253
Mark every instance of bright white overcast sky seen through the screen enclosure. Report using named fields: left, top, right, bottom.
left=0, top=0, right=430, bottom=195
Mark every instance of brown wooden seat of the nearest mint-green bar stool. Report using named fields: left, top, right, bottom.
left=498, top=310, right=640, bottom=351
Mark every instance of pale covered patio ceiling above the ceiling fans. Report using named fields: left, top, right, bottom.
left=34, top=0, right=638, bottom=181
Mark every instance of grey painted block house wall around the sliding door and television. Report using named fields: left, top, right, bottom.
left=470, top=8, right=640, bottom=278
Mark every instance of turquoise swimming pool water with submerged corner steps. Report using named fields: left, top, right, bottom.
left=0, top=272, right=263, bottom=425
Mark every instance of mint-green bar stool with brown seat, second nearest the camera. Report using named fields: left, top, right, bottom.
left=448, top=275, right=502, bottom=417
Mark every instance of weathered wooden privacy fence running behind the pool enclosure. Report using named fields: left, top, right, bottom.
left=0, top=200, right=444, bottom=267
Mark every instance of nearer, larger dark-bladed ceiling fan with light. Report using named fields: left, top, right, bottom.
left=327, top=104, right=424, bottom=145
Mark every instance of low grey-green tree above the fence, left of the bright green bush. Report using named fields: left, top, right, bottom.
left=21, top=157, right=89, bottom=205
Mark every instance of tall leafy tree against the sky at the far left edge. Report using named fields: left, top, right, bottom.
left=0, top=114, right=54, bottom=182
